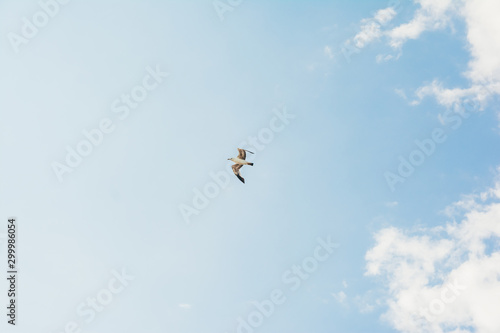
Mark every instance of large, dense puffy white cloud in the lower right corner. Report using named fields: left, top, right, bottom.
left=365, top=175, right=500, bottom=333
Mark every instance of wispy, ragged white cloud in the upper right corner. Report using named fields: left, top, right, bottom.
left=345, top=0, right=500, bottom=110
